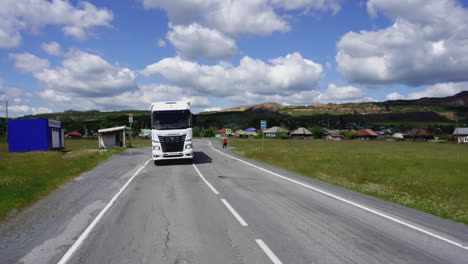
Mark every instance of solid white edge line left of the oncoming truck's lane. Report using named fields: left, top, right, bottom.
left=58, top=160, right=151, bottom=264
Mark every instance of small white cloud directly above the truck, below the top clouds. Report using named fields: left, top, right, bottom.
left=167, top=23, right=237, bottom=61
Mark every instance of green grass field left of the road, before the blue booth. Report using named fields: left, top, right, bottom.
left=0, top=140, right=151, bottom=220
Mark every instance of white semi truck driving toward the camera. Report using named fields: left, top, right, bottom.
left=151, top=101, right=193, bottom=165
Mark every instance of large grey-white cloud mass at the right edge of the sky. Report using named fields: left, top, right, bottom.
left=336, top=0, right=468, bottom=86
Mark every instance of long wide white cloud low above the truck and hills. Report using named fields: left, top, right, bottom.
left=141, top=53, right=323, bottom=96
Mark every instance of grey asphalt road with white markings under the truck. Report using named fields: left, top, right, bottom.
left=0, top=141, right=468, bottom=264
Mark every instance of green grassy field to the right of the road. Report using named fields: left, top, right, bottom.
left=230, top=139, right=468, bottom=224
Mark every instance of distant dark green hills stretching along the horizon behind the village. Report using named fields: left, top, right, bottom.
left=11, top=92, right=468, bottom=133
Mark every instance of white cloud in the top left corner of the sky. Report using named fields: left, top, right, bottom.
left=0, top=0, right=113, bottom=48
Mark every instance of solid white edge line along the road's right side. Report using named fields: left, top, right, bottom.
left=211, top=147, right=468, bottom=250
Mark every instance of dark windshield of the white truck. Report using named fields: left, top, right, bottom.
left=153, top=110, right=191, bottom=130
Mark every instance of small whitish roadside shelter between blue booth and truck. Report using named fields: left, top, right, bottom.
left=98, top=126, right=132, bottom=148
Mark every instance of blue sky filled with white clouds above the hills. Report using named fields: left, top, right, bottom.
left=0, top=0, right=468, bottom=116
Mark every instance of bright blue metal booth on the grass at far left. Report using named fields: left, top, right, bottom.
left=8, top=118, right=65, bottom=152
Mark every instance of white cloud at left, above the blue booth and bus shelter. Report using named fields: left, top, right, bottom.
left=34, top=50, right=138, bottom=97
